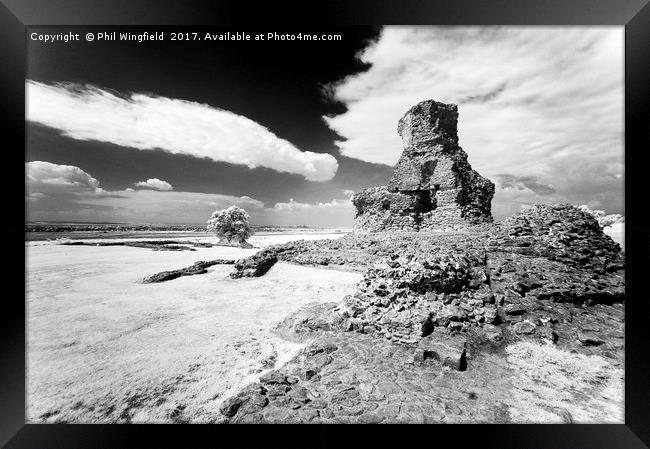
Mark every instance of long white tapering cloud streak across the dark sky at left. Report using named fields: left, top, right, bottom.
left=26, top=80, right=338, bottom=181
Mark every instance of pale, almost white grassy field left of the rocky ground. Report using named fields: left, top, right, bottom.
left=27, top=236, right=360, bottom=423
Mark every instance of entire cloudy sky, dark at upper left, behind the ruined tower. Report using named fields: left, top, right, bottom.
left=25, top=26, right=624, bottom=227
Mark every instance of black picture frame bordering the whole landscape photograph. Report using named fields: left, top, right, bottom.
left=0, top=0, right=650, bottom=449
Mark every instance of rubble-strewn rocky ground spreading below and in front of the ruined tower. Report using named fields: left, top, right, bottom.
left=216, top=205, right=625, bottom=422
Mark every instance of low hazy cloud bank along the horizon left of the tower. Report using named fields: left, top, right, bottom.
left=25, top=161, right=354, bottom=227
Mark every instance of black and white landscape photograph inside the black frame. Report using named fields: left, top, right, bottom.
left=24, top=25, right=624, bottom=424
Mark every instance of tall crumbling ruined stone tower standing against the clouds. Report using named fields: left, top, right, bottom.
left=352, top=100, right=494, bottom=232
